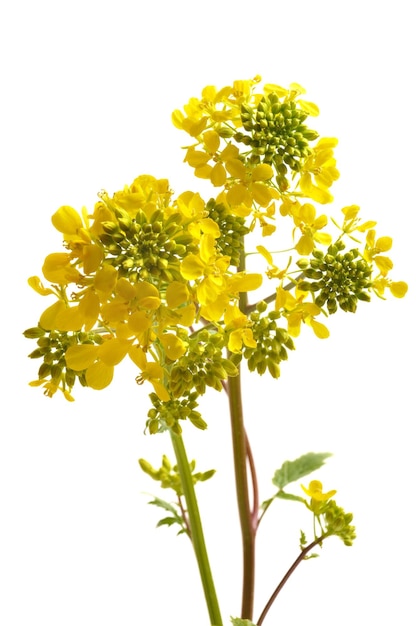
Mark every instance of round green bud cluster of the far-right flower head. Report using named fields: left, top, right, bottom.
left=299, top=241, right=372, bottom=314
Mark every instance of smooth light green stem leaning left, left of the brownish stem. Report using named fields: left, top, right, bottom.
left=170, top=431, right=222, bottom=626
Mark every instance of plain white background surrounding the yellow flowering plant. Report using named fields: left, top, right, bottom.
left=0, top=0, right=416, bottom=626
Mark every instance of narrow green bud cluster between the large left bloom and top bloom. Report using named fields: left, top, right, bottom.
left=207, top=199, right=250, bottom=267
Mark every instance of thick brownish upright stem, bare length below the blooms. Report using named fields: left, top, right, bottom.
left=228, top=374, right=257, bottom=620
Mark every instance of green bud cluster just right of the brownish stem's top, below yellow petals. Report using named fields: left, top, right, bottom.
left=234, top=302, right=295, bottom=378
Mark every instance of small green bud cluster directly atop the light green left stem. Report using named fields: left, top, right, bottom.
left=146, top=391, right=207, bottom=435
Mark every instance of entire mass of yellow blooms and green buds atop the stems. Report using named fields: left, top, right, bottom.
left=25, top=77, right=407, bottom=432
